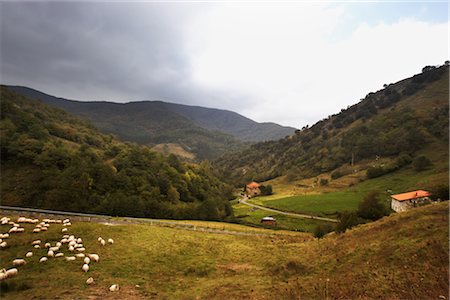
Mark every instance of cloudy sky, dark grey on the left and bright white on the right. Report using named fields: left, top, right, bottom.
left=0, top=1, right=449, bottom=128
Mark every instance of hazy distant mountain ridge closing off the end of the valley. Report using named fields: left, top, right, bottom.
left=8, top=86, right=295, bottom=160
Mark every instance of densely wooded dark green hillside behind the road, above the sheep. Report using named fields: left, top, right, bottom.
left=0, top=87, right=236, bottom=220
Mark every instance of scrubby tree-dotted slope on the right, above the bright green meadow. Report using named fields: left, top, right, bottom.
left=215, top=64, right=449, bottom=185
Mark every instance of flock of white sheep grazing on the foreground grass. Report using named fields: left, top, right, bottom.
left=0, top=217, right=119, bottom=292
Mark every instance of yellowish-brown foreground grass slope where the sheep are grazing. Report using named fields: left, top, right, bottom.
left=0, top=202, right=449, bottom=299
